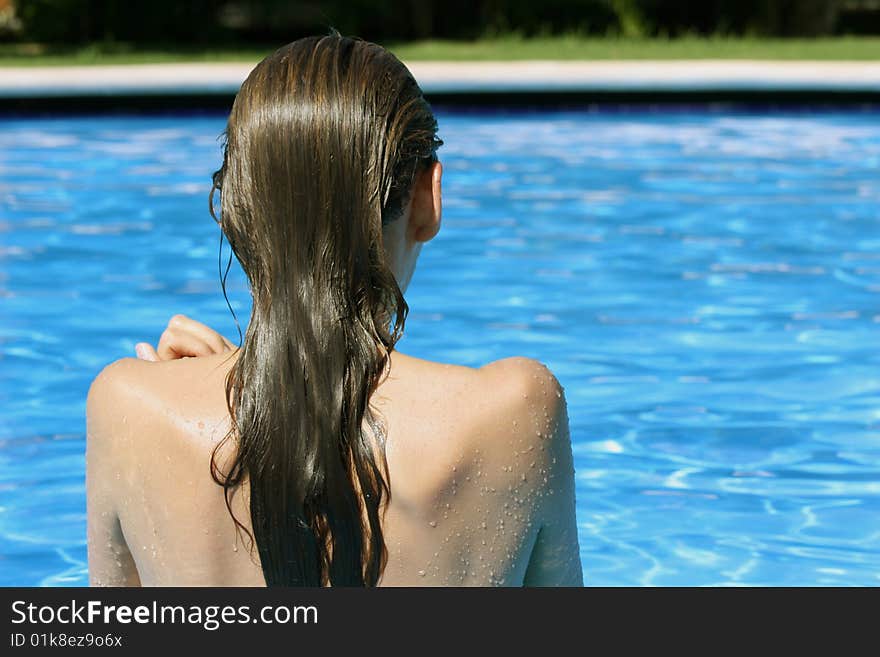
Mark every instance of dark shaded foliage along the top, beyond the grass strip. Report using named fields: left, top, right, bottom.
left=0, top=0, right=880, bottom=46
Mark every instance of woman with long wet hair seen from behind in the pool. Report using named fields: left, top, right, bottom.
left=87, top=35, right=581, bottom=586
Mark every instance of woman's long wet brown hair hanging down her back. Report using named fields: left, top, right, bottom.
left=211, top=32, right=442, bottom=586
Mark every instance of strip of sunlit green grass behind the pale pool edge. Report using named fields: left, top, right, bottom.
left=0, top=36, right=880, bottom=66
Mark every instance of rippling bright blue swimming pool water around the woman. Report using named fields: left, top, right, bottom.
left=0, top=112, right=880, bottom=585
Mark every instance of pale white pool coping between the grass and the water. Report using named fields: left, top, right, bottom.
left=0, top=60, right=880, bottom=98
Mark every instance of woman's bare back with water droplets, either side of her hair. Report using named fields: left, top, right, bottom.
left=87, top=352, right=582, bottom=586
